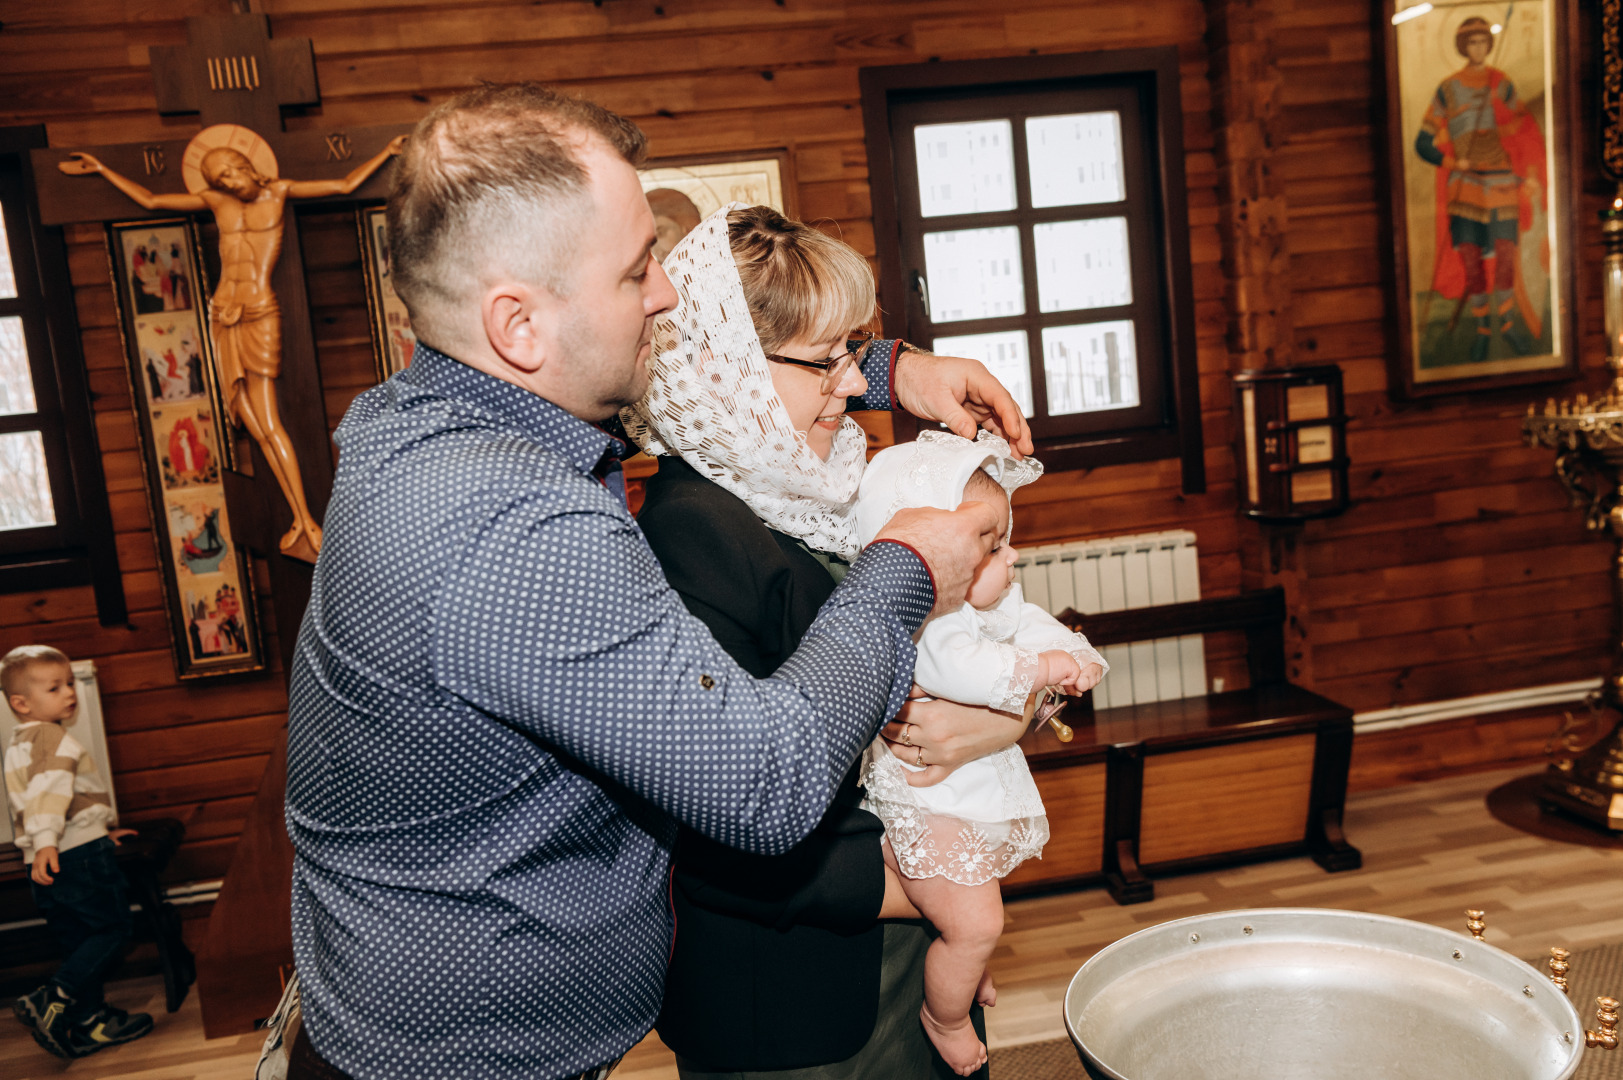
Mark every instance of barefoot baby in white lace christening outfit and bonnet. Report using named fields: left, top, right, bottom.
left=857, top=432, right=1109, bottom=1075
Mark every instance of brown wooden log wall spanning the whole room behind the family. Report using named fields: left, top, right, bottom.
left=0, top=0, right=1612, bottom=879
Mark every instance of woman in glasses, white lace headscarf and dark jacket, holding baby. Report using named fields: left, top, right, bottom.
left=622, top=205, right=1018, bottom=1080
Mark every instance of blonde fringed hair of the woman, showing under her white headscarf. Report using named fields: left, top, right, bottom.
left=727, top=206, right=878, bottom=352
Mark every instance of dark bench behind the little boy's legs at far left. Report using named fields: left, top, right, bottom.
left=0, top=819, right=196, bottom=1012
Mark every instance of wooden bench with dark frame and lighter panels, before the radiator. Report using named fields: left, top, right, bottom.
left=1003, top=588, right=1362, bottom=903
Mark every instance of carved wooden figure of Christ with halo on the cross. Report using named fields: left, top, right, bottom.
left=58, top=135, right=406, bottom=562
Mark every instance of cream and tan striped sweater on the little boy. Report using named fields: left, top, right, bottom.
left=5, top=721, right=112, bottom=862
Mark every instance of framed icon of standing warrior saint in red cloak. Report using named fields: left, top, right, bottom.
left=1383, top=0, right=1578, bottom=398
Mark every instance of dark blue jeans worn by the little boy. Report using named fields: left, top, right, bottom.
left=34, top=836, right=135, bottom=1023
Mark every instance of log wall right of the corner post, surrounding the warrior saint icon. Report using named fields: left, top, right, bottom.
left=1278, top=0, right=1615, bottom=710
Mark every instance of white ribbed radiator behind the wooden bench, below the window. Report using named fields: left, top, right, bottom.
left=1014, top=529, right=1206, bottom=708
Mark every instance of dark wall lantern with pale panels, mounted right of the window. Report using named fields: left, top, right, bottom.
left=1233, top=364, right=1347, bottom=521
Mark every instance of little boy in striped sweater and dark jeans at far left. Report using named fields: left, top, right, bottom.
left=0, top=645, right=153, bottom=1057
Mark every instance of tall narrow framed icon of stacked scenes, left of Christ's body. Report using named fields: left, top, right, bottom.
left=109, top=218, right=265, bottom=679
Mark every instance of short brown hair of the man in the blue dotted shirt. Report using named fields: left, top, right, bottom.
left=388, top=83, right=648, bottom=333
